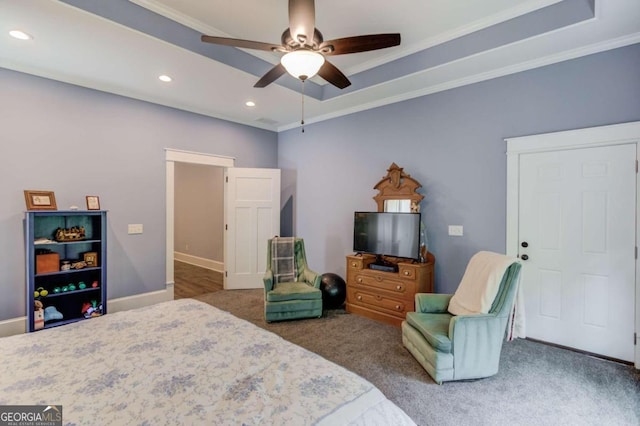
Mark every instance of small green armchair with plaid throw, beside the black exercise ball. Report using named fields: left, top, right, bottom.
left=263, top=238, right=322, bottom=322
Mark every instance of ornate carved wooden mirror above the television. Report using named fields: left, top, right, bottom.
left=373, top=163, right=424, bottom=212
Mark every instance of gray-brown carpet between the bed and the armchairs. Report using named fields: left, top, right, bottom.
left=196, top=290, right=640, bottom=425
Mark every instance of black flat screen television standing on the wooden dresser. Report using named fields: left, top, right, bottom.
left=353, top=212, right=420, bottom=260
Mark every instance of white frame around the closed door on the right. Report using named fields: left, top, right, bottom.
left=504, top=121, right=640, bottom=369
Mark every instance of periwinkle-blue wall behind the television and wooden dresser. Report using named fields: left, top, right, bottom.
left=278, top=45, right=640, bottom=293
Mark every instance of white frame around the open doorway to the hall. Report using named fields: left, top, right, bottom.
left=165, top=148, right=236, bottom=300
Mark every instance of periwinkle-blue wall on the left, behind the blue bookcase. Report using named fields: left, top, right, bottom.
left=0, top=69, right=277, bottom=320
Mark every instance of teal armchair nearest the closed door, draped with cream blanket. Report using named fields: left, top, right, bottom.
left=402, top=262, right=521, bottom=384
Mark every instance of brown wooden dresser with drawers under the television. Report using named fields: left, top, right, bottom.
left=346, top=253, right=435, bottom=326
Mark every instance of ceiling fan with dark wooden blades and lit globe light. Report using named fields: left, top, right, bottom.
left=202, top=0, right=400, bottom=89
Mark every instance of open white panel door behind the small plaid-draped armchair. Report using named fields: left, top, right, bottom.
left=224, top=167, right=280, bottom=290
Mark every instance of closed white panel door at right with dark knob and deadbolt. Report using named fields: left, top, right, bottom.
left=518, top=144, right=636, bottom=361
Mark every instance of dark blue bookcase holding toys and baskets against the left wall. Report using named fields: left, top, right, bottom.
left=25, top=210, right=107, bottom=332
